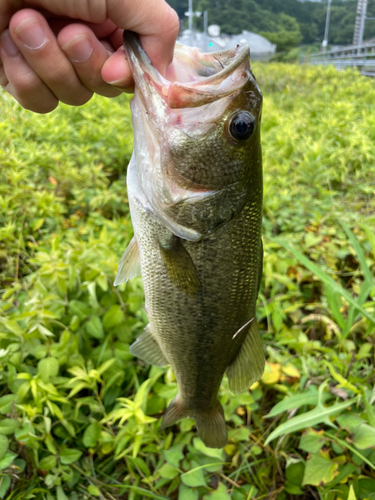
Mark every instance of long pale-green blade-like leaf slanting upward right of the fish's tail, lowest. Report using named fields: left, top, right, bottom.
left=265, top=382, right=356, bottom=444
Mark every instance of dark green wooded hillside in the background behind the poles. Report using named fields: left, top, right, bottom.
left=169, top=0, right=375, bottom=51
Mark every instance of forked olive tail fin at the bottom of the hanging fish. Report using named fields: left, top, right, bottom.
left=160, top=397, right=228, bottom=448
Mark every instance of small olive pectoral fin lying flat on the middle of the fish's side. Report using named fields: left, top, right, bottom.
left=159, top=233, right=200, bottom=296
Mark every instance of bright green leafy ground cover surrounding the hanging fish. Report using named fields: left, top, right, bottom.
left=0, top=64, right=375, bottom=500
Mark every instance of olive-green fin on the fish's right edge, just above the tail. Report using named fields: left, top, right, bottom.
left=227, top=320, right=265, bottom=393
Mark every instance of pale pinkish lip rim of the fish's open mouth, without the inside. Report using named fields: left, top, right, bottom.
left=123, top=31, right=251, bottom=109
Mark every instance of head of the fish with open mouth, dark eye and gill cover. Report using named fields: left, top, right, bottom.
left=124, top=32, right=262, bottom=237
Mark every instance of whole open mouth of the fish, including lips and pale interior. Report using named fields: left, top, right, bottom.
left=123, top=31, right=252, bottom=110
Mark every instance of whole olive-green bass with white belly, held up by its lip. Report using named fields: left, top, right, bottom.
left=115, top=31, right=265, bottom=448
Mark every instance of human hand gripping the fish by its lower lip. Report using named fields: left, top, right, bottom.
left=0, top=0, right=179, bottom=113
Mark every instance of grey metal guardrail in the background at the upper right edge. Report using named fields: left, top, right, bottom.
left=306, top=43, right=375, bottom=77
